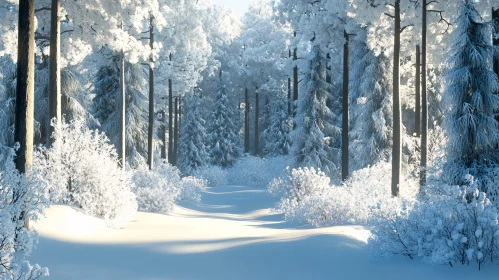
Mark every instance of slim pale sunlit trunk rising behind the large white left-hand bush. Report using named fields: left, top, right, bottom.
left=118, top=50, right=126, bottom=170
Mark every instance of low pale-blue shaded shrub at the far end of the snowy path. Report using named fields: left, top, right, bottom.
left=227, top=156, right=294, bottom=188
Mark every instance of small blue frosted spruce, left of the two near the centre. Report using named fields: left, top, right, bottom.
left=180, top=96, right=209, bottom=173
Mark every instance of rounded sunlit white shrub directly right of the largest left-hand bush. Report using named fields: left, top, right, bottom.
left=133, top=162, right=181, bottom=214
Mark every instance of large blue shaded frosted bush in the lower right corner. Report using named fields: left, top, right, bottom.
left=370, top=180, right=499, bottom=269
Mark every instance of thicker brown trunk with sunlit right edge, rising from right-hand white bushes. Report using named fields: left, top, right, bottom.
left=392, top=0, right=402, bottom=197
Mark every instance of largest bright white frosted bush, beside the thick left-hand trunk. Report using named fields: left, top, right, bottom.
left=34, top=119, right=137, bottom=228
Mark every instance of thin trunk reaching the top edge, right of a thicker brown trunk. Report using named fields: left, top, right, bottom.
left=420, top=0, right=428, bottom=189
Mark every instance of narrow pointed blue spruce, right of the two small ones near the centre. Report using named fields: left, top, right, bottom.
left=209, top=75, right=242, bottom=167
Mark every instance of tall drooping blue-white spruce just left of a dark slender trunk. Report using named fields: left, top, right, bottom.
left=292, top=46, right=340, bottom=174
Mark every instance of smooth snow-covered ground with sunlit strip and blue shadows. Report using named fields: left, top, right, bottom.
left=33, top=186, right=499, bottom=280
